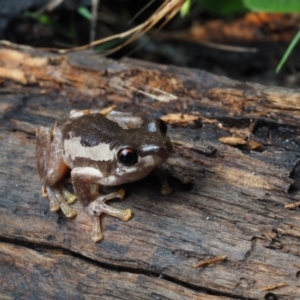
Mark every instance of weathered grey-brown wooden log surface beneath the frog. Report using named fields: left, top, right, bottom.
left=0, top=47, right=300, bottom=300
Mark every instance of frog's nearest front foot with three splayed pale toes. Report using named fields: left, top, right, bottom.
left=87, top=189, right=131, bottom=242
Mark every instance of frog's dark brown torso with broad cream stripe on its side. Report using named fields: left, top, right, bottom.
left=58, top=114, right=124, bottom=171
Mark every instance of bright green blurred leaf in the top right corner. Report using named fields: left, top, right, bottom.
left=244, top=0, right=300, bottom=13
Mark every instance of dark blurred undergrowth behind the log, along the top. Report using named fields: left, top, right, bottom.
left=0, top=0, right=300, bottom=87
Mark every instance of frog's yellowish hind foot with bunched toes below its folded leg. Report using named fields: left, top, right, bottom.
left=43, top=184, right=76, bottom=218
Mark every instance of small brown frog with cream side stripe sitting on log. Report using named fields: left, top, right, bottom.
left=36, top=107, right=190, bottom=242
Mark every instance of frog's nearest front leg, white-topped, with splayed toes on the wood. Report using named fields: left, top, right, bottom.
left=71, top=167, right=131, bottom=242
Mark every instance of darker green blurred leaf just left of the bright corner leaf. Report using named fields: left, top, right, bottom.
left=196, top=0, right=246, bottom=16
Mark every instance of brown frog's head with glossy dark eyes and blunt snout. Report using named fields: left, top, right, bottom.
left=113, top=119, right=173, bottom=181
